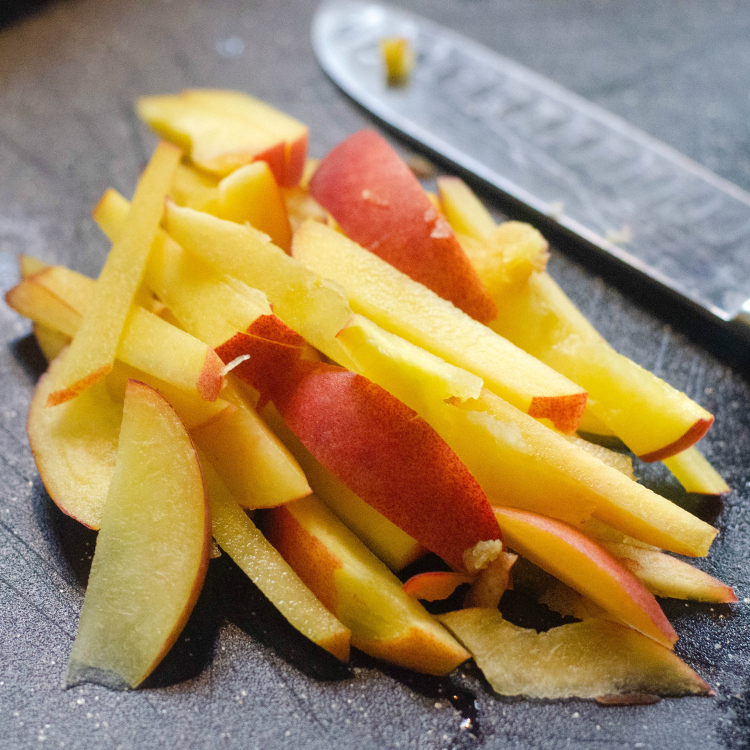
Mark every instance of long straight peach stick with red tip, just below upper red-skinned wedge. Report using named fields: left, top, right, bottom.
left=294, top=220, right=586, bottom=432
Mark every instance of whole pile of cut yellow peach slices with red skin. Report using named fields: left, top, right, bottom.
left=6, top=90, right=736, bottom=702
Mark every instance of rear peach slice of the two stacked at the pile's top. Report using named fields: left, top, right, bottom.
left=182, top=89, right=308, bottom=187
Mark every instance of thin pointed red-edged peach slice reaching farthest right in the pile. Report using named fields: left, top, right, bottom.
left=599, top=542, right=737, bottom=604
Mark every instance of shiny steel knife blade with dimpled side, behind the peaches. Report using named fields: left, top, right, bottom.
left=312, top=0, right=750, bottom=335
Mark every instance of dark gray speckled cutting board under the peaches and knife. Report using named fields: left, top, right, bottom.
left=0, top=0, right=750, bottom=750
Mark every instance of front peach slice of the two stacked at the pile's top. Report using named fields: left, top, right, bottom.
left=136, top=95, right=285, bottom=184
